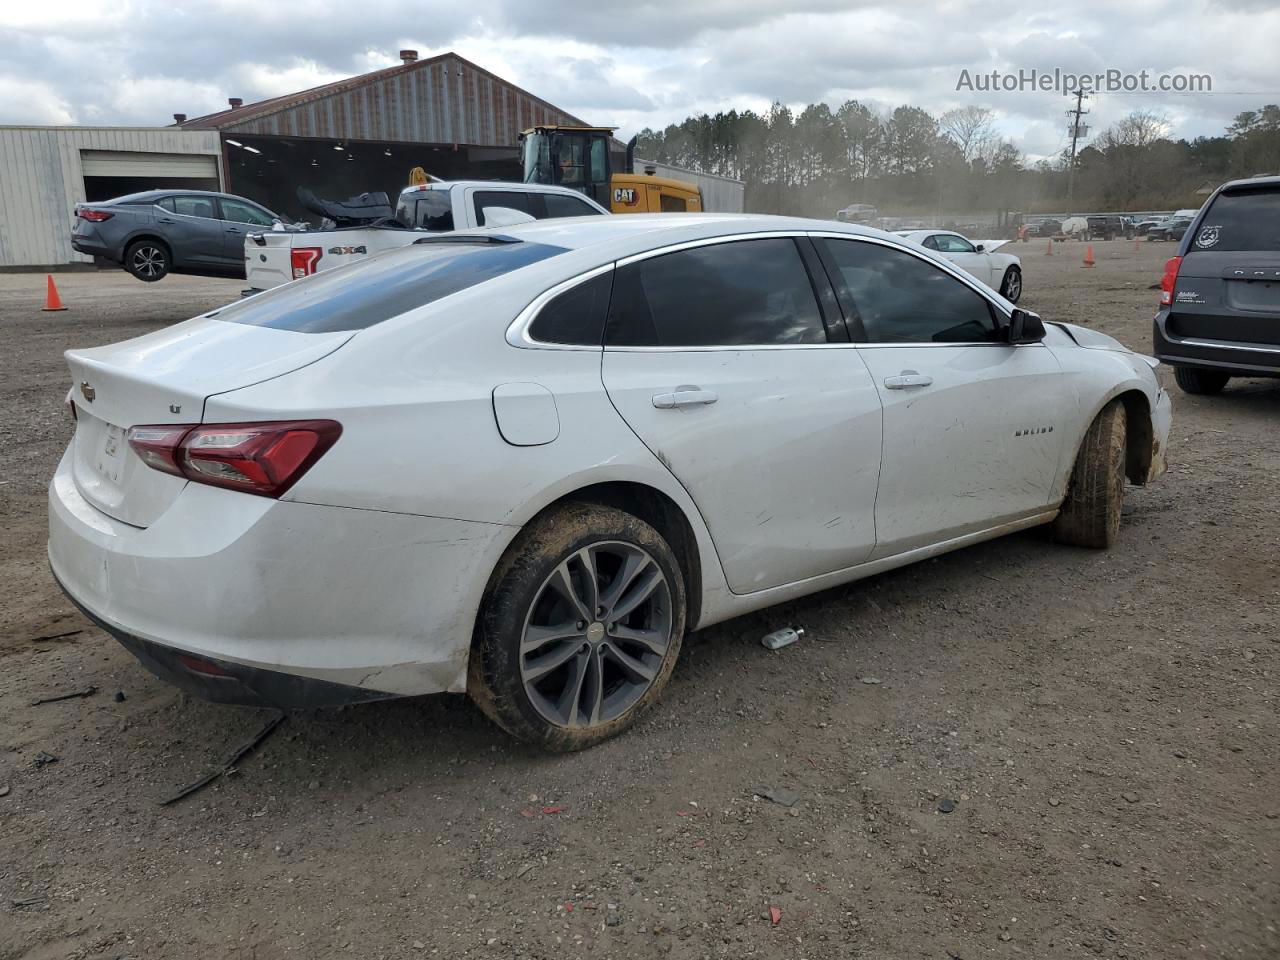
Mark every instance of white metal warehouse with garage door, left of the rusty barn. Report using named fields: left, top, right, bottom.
left=0, top=127, right=224, bottom=269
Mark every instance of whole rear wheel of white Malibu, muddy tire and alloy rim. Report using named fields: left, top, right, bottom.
left=467, top=503, right=685, bottom=751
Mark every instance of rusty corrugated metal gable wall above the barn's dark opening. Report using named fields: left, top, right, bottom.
left=221, top=58, right=581, bottom=147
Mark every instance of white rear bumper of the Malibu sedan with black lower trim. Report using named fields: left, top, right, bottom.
left=49, top=448, right=515, bottom=707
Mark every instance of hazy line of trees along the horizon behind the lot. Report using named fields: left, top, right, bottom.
left=637, top=100, right=1280, bottom=216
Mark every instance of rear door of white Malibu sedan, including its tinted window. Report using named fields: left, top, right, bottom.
left=602, top=236, right=881, bottom=594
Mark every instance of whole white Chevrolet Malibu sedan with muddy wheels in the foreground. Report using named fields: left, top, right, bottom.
left=49, top=215, right=1170, bottom=749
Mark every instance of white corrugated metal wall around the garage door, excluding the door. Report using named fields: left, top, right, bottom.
left=0, top=127, right=221, bottom=266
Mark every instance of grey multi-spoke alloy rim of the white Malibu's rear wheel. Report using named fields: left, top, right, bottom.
left=520, top=540, right=673, bottom=727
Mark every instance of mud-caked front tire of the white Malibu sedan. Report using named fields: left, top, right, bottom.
left=1053, top=399, right=1126, bottom=550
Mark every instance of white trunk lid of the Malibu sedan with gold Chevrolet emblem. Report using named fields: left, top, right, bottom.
left=67, top=311, right=353, bottom=527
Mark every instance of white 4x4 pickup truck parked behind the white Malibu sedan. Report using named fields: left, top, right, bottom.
left=244, top=180, right=609, bottom=296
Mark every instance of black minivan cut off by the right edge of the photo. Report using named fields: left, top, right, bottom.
left=1153, top=177, right=1280, bottom=393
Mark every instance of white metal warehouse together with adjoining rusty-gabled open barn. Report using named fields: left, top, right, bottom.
left=0, top=50, right=582, bottom=269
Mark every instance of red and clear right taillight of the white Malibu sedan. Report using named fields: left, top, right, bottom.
left=129, top=420, right=342, bottom=497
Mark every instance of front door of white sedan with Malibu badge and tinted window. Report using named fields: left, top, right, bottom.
left=815, top=237, right=1076, bottom=559
